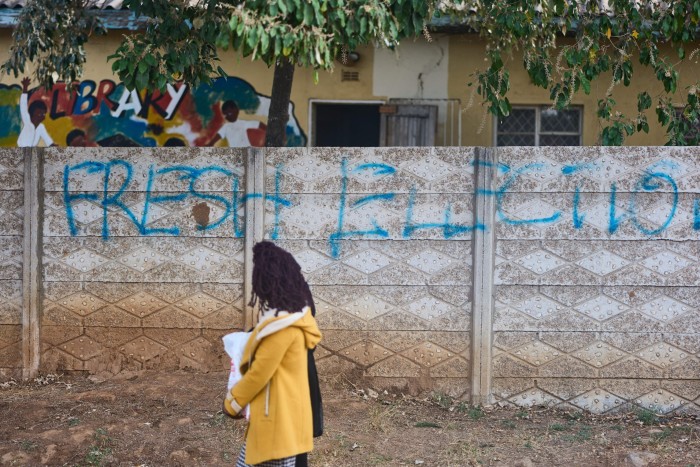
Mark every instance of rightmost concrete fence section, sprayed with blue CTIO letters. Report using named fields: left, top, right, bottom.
left=492, top=148, right=700, bottom=413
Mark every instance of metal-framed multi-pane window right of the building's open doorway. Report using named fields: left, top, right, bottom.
left=496, top=106, right=582, bottom=146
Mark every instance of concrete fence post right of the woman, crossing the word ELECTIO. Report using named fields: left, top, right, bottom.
left=471, top=148, right=497, bottom=405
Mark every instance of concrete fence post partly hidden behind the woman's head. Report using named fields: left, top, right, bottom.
left=243, top=148, right=265, bottom=329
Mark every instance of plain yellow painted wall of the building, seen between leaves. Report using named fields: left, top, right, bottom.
left=0, top=29, right=700, bottom=146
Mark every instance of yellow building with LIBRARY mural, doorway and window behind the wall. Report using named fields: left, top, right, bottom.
left=0, top=0, right=700, bottom=147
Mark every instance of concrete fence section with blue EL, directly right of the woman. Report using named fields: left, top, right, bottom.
left=265, top=148, right=474, bottom=396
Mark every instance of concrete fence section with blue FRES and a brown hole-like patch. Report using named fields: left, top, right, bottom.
left=41, top=148, right=245, bottom=373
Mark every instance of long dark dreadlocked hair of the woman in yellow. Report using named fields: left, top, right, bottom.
left=250, top=241, right=316, bottom=316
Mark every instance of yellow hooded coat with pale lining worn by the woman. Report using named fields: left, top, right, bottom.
left=224, top=308, right=321, bottom=465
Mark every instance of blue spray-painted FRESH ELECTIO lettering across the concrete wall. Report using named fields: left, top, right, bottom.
left=63, top=158, right=700, bottom=257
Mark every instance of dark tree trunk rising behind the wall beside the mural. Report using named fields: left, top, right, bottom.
left=265, top=58, right=294, bottom=148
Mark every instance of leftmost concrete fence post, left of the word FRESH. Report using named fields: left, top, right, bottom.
left=21, top=148, right=44, bottom=379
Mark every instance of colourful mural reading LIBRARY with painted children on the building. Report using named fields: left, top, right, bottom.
left=0, top=77, right=306, bottom=147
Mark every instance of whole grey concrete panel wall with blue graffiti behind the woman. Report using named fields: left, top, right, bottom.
left=0, top=147, right=700, bottom=412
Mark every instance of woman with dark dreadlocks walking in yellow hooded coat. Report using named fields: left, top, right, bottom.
left=224, top=242, right=321, bottom=467
